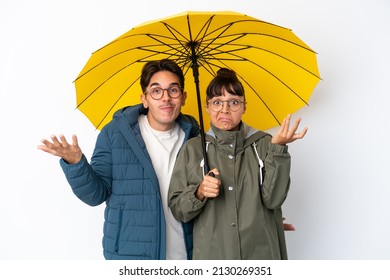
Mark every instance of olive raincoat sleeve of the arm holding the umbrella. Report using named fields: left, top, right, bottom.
left=168, top=142, right=207, bottom=222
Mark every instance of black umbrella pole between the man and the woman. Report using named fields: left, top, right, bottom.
left=191, top=45, right=210, bottom=174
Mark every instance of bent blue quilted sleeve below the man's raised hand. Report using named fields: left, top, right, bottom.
left=60, top=129, right=112, bottom=206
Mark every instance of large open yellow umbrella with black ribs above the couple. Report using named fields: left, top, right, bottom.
left=75, top=12, right=320, bottom=173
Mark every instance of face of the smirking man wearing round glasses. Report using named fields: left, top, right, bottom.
left=141, top=71, right=187, bottom=131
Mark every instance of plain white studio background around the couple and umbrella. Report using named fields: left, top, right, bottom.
left=0, top=0, right=390, bottom=260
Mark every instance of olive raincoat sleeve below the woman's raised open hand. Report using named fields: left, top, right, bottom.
left=261, top=143, right=291, bottom=209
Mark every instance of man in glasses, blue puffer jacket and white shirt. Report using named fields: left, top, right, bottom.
left=38, top=59, right=199, bottom=260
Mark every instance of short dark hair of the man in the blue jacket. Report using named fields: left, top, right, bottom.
left=140, top=59, right=184, bottom=92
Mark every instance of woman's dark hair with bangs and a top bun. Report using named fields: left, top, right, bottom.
left=206, top=68, right=245, bottom=100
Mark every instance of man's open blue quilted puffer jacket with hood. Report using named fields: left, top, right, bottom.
left=60, top=104, right=199, bottom=260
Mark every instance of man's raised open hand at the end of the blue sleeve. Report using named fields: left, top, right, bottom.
left=37, top=134, right=83, bottom=164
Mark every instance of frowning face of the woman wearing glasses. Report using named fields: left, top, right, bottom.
left=206, top=89, right=245, bottom=130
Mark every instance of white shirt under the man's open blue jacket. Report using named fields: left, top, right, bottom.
left=138, top=115, right=187, bottom=260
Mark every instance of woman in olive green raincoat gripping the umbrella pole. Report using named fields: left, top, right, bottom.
left=168, top=68, right=307, bottom=259
